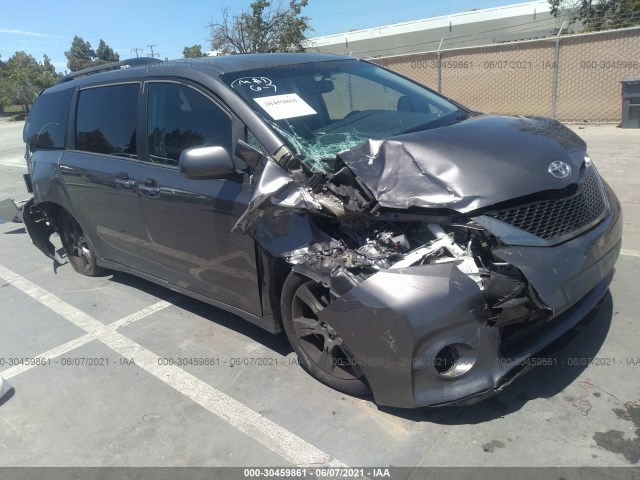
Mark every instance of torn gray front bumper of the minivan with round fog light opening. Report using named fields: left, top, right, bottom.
left=320, top=182, right=622, bottom=408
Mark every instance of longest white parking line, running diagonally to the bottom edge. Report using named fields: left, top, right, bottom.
left=0, top=265, right=346, bottom=467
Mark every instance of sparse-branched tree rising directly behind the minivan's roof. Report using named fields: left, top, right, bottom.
left=209, top=0, right=310, bottom=53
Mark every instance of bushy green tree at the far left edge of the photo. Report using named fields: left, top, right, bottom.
left=0, top=52, right=60, bottom=112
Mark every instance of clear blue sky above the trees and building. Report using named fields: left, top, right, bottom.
left=0, top=0, right=521, bottom=71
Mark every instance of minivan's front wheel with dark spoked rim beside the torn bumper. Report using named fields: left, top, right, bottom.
left=280, top=272, right=371, bottom=395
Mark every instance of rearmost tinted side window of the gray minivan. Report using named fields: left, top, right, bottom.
left=22, top=88, right=73, bottom=150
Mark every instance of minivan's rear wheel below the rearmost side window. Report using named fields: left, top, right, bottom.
left=56, top=210, right=104, bottom=277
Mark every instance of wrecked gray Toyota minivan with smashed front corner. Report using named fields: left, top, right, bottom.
left=23, top=54, right=622, bottom=407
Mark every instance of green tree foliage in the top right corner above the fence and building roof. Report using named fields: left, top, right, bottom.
left=549, top=0, right=640, bottom=31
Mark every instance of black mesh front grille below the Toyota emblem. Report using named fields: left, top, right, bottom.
left=487, top=168, right=606, bottom=240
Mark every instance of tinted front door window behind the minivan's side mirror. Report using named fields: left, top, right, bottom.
left=147, top=83, right=231, bottom=165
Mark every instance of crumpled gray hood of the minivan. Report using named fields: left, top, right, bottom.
left=339, top=115, right=586, bottom=213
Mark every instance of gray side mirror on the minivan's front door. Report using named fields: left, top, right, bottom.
left=178, top=147, right=235, bottom=180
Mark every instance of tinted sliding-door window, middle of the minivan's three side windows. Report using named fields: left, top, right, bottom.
left=76, top=83, right=140, bottom=158
